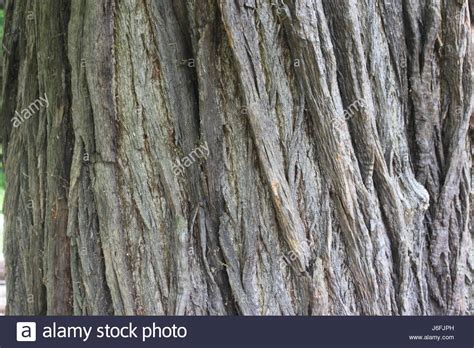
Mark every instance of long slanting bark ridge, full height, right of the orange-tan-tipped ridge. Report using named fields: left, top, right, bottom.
left=280, top=2, right=379, bottom=313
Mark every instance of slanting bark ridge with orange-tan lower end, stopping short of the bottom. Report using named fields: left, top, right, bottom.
left=221, top=1, right=309, bottom=272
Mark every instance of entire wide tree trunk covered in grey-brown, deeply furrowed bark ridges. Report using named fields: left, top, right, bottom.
left=0, top=0, right=474, bottom=315
